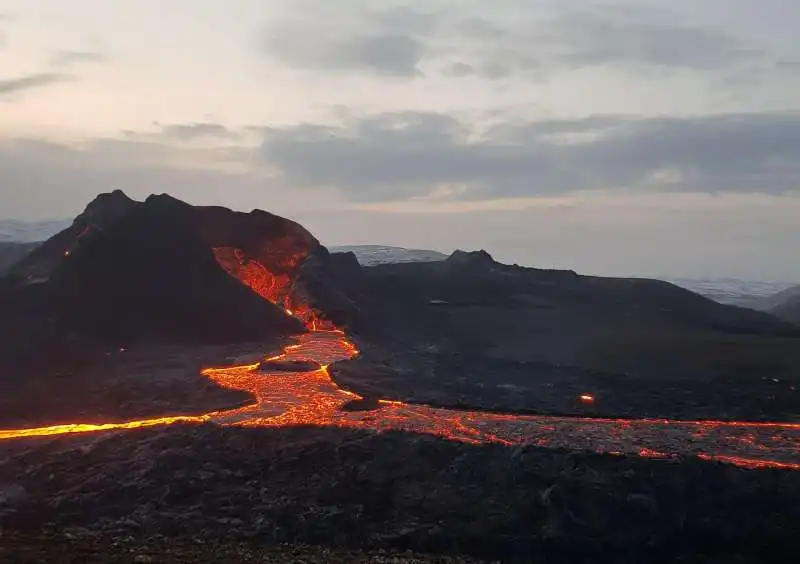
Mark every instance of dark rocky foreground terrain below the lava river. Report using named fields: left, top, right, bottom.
left=0, top=425, right=800, bottom=562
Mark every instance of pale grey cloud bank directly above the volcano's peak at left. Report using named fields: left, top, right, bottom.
left=0, top=134, right=275, bottom=217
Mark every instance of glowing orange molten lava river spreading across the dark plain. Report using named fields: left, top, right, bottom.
left=0, top=331, right=800, bottom=470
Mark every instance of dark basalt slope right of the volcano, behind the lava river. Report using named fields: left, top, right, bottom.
left=332, top=252, right=800, bottom=419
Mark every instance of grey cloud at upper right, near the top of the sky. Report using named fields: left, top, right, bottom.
left=458, top=7, right=761, bottom=79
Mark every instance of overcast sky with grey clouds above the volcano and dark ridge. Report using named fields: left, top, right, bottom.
left=0, top=0, right=800, bottom=282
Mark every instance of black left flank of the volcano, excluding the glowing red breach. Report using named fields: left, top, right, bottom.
left=0, top=192, right=302, bottom=350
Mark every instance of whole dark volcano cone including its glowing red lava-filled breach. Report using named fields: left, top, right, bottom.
left=0, top=191, right=350, bottom=346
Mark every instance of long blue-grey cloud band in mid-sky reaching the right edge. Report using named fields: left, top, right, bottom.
left=262, top=113, right=800, bottom=201
